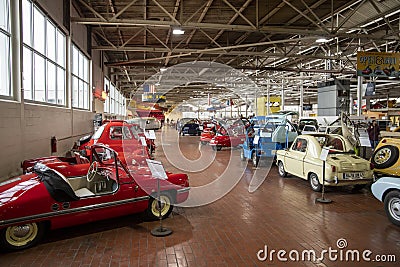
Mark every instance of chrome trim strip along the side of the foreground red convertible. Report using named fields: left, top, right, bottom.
left=0, top=196, right=150, bottom=226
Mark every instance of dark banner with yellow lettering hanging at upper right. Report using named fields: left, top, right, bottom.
left=357, top=51, right=400, bottom=78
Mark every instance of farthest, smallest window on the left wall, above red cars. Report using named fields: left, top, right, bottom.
left=104, top=77, right=126, bottom=116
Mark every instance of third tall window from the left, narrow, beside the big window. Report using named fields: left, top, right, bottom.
left=71, top=45, right=90, bottom=109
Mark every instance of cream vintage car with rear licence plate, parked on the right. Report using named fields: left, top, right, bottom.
left=276, top=134, right=373, bottom=191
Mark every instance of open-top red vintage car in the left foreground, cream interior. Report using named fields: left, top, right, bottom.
left=0, top=145, right=189, bottom=250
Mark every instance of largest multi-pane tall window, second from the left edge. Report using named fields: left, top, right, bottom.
left=22, top=0, right=66, bottom=105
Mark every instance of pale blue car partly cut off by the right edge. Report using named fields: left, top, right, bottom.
left=371, top=177, right=400, bottom=226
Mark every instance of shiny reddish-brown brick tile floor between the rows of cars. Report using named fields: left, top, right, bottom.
left=0, top=127, right=400, bottom=267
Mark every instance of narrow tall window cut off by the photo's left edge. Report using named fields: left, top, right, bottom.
left=0, top=0, right=11, bottom=96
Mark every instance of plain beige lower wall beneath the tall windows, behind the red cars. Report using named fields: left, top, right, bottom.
left=0, top=101, right=94, bottom=180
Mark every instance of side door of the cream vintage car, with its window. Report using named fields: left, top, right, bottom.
left=285, top=138, right=307, bottom=180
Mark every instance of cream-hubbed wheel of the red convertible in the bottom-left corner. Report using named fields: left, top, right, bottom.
left=0, top=222, right=46, bottom=251
